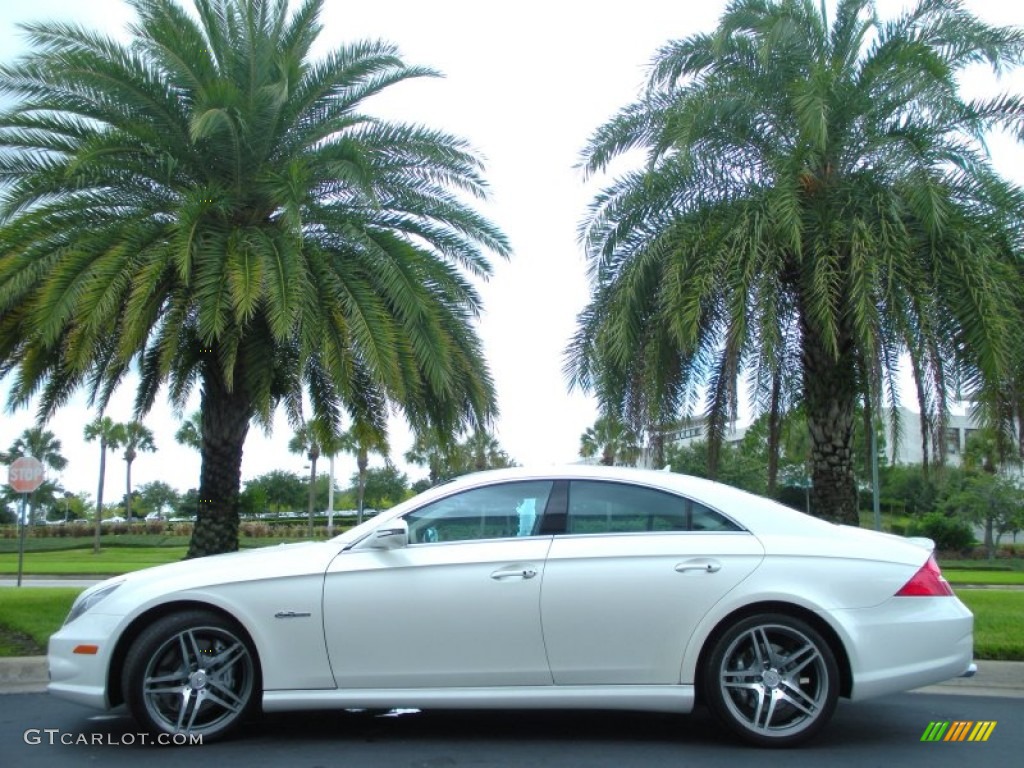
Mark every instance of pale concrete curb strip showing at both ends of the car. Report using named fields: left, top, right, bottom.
left=0, top=656, right=1024, bottom=698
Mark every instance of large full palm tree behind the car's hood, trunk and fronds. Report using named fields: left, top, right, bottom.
left=0, top=0, right=509, bottom=556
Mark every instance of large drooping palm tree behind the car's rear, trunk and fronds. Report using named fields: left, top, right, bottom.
left=566, top=0, right=1024, bottom=524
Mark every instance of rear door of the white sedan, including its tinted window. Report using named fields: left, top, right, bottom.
left=541, top=480, right=764, bottom=685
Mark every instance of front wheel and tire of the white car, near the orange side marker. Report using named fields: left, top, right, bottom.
left=123, top=610, right=260, bottom=742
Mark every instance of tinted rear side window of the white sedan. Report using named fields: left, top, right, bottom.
left=566, top=480, right=740, bottom=534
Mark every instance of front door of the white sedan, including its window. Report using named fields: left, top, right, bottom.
left=324, top=480, right=553, bottom=688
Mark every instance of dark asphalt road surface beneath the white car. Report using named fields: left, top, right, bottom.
left=0, top=693, right=1024, bottom=768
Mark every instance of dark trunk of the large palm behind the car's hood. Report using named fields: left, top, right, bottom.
left=187, top=364, right=252, bottom=557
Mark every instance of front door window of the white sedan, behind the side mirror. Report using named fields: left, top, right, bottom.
left=404, top=480, right=554, bottom=544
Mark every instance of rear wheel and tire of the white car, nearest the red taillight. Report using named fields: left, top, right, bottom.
left=702, top=613, right=840, bottom=746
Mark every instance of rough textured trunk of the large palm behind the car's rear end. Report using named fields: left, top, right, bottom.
left=802, top=322, right=859, bottom=525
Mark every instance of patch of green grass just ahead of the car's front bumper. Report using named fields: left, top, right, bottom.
left=0, top=587, right=82, bottom=656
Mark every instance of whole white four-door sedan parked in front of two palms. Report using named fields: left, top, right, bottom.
left=49, top=467, right=973, bottom=745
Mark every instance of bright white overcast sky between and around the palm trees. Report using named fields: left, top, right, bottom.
left=0, top=0, right=1024, bottom=499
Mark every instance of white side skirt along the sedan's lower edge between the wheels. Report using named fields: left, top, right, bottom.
left=263, top=685, right=694, bottom=713
